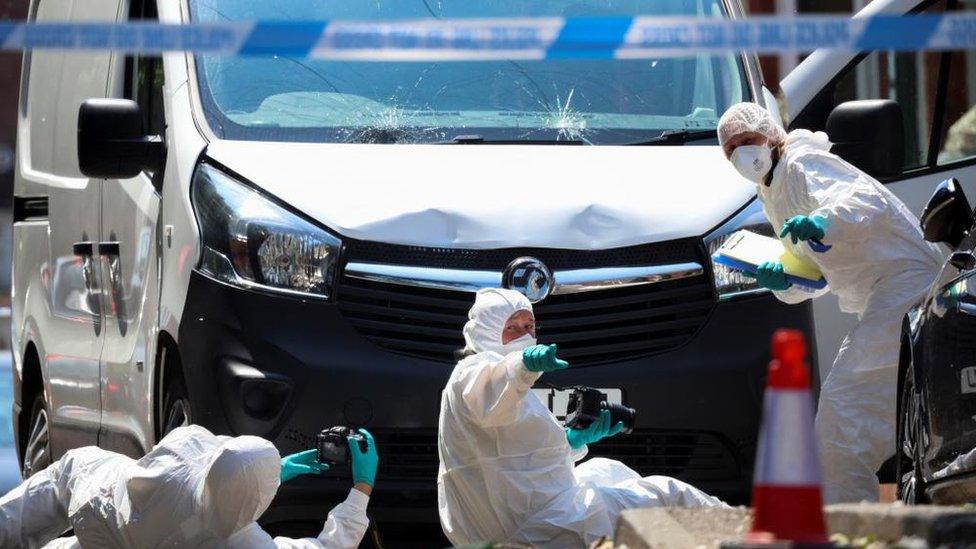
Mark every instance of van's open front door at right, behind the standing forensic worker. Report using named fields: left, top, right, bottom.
left=782, top=0, right=976, bottom=378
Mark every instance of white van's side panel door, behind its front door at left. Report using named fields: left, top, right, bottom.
left=21, top=0, right=118, bottom=457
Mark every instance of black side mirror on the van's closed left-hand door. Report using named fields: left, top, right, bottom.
left=78, top=99, right=164, bottom=179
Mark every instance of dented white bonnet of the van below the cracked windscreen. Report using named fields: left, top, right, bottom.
left=207, top=141, right=755, bottom=250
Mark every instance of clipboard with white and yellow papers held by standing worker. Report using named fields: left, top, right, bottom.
left=712, top=230, right=827, bottom=290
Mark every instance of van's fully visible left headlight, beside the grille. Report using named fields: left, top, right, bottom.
left=190, top=164, right=342, bottom=298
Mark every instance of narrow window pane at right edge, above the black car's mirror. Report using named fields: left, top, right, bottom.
left=938, top=0, right=976, bottom=165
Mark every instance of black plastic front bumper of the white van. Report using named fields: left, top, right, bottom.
left=178, top=273, right=817, bottom=522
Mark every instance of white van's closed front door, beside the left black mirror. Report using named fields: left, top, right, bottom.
left=99, top=0, right=166, bottom=457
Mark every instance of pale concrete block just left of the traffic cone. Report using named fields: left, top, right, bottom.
left=614, top=507, right=751, bottom=549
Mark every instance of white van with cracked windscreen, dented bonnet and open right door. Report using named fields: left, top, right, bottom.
left=12, top=0, right=976, bottom=522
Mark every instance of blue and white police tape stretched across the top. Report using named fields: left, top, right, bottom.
left=0, top=13, right=976, bottom=61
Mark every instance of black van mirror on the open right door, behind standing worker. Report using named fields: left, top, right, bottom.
left=826, top=99, right=905, bottom=177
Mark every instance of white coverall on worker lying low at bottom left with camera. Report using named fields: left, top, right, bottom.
left=0, top=425, right=369, bottom=549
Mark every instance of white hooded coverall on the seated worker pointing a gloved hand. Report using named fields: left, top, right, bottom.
left=437, top=289, right=724, bottom=548
